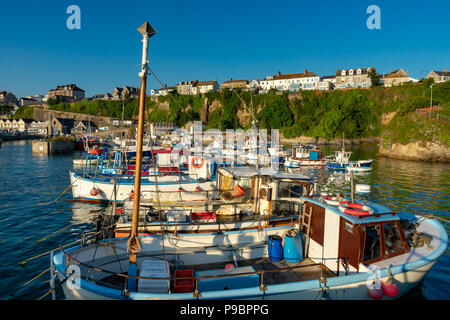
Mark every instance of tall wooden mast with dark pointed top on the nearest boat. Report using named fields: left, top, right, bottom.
left=128, top=22, right=156, bottom=280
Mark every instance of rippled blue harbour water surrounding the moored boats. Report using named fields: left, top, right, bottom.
left=0, top=141, right=450, bottom=300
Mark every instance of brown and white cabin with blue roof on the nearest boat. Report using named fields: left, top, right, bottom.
left=302, top=197, right=409, bottom=275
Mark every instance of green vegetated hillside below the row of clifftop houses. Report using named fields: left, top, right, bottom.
left=46, top=79, right=450, bottom=145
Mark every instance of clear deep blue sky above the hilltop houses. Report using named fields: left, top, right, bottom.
left=0, top=0, right=450, bottom=97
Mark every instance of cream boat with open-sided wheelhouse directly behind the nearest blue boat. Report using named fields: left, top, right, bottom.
left=116, top=167, right=314, bottom=237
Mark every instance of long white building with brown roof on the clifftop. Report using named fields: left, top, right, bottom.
left=260, top=69, right=320, bottom=92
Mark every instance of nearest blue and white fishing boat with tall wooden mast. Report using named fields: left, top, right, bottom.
left=50, top=22, right=448, bottom=300
